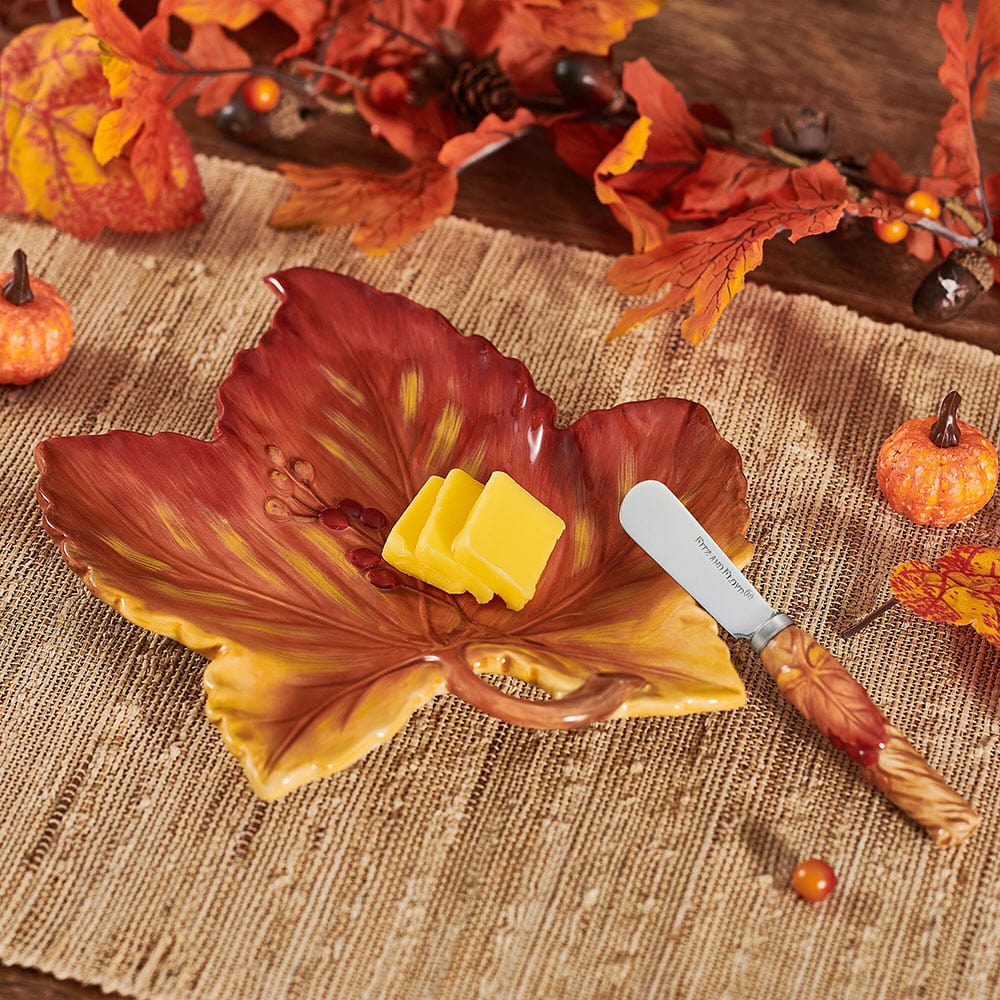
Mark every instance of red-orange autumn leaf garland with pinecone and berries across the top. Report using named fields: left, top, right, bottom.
left=0, top=0, right=1000, bottom=343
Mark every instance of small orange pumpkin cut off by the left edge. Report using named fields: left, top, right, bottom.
left=0, top=250, right=73, bottom=385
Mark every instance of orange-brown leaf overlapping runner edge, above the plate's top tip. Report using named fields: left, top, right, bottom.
left=270, top=158, right=458, bottom=255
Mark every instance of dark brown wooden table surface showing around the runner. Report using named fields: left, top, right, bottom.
left=0, top=0, right=1000, bottom=1000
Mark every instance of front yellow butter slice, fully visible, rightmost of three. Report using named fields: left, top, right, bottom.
left=452, top=472, right=566, bottom=611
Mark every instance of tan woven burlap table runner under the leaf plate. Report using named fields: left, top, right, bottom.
left=0, top=152, right=1000, bottom=1000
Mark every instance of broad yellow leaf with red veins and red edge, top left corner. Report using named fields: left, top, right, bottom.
left=0, top=18, right=204, bottom=239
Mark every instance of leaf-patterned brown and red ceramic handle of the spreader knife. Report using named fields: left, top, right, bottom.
left=760, top=625, right=981, bottom=847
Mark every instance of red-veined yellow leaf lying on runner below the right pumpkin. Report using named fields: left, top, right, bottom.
left=889, top=545, right=1000, bottom=646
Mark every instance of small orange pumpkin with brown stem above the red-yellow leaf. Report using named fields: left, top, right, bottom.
left=877, top=392, right=997, bottom=528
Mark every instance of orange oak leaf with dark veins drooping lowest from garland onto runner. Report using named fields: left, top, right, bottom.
left=608, top=160, right=850, bottom=344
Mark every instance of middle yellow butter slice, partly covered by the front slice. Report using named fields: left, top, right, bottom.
left=414, top=469, right=493, bottom=604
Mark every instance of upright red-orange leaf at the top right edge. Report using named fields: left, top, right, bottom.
left=931, top=0, right=1000, bottom=189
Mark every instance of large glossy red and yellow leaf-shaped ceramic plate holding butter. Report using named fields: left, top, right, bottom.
left=36, top=268, right=751, bottom=798
